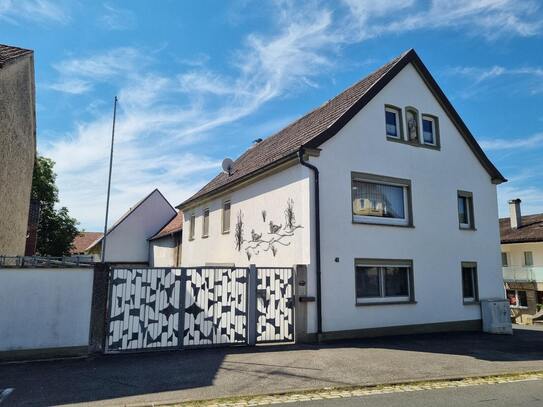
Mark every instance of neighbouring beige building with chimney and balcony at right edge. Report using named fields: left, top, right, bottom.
left=500, top=199, right=543, bottom=324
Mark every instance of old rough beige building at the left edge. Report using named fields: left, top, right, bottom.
left=0, top=44, right=36, bottom=256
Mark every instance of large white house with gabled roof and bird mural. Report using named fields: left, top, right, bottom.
left=178, top=50, right=506, bottom=338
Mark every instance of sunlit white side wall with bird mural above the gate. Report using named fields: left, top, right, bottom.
left=182, top=165, right=310, bottom=267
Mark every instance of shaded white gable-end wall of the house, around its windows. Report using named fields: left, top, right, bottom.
left=312, top=65, right=504, bottom=331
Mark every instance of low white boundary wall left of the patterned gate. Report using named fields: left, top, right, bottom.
left=0, top=268, right=93, bottom=351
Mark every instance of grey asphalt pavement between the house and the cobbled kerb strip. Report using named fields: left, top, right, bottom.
left=0, top=328, right=543, bottom=407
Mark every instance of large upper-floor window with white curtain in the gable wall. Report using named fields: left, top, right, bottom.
left=351, top=173, right=412, bottom=226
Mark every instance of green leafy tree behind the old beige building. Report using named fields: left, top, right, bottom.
left=32, top=156, right=79, bottom=256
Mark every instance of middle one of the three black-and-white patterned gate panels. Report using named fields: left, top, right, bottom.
left=183, top=268, right=248, bottom=346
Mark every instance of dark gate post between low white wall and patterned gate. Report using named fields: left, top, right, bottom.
left=89, top=263, right=110, bottom=354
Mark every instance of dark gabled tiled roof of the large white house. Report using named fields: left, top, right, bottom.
left=178, top=49, right=506, bottom=208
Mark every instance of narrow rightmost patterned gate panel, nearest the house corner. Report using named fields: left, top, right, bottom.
left=256, top=268, right=294, bottom=342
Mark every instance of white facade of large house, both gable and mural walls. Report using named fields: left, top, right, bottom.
left=183, top=60, right=504, bottom=332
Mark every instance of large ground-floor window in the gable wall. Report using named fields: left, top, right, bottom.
left=355, top=259, right=414, bottom=304
